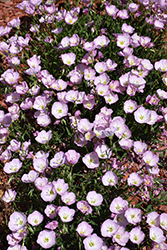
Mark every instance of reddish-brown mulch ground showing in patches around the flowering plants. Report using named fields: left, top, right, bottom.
left=0, top=0, right=167, bottom=250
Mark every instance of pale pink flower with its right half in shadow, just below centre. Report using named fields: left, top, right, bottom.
left=82, top=151, right=99, bottom=169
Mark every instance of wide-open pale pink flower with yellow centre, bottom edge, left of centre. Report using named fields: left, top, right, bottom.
left=37, top=230, right=56, bottom=249
